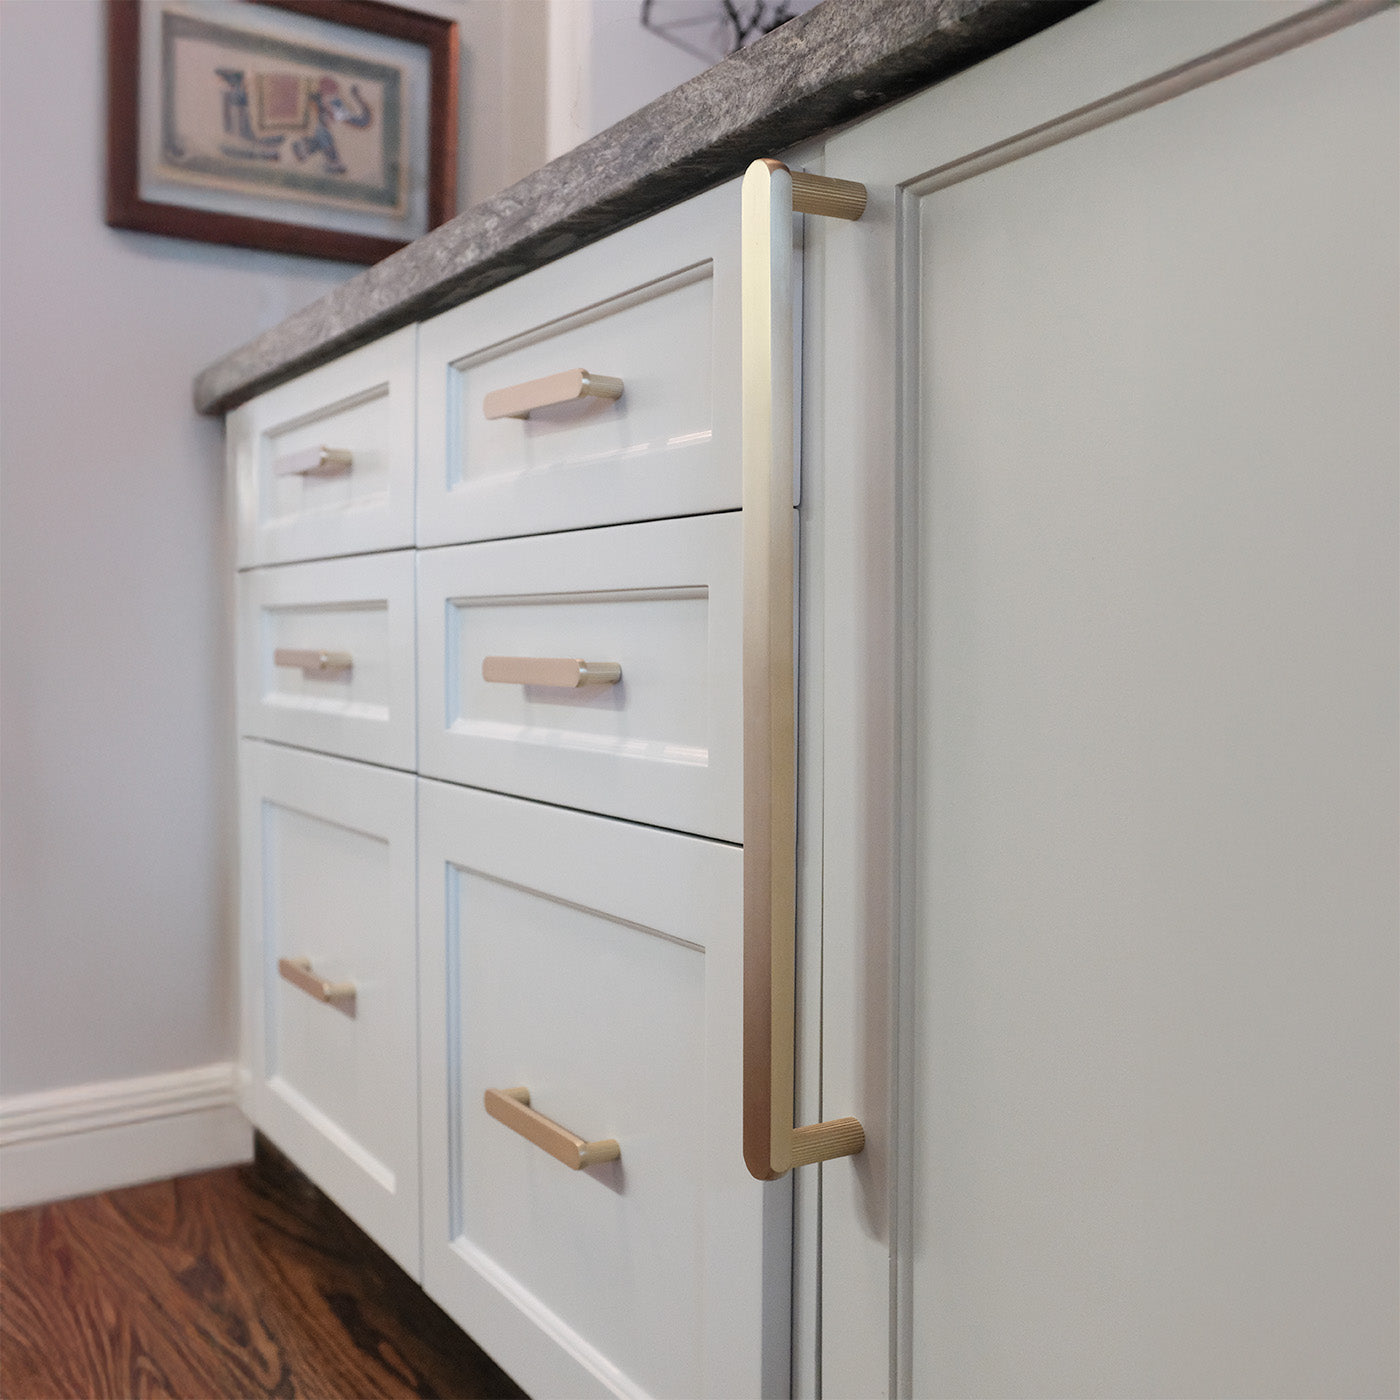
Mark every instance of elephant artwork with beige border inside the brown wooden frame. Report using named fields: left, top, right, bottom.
left=160, top=10, right=407, bottom=213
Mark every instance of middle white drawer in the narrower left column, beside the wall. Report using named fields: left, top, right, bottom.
left=238, top=550, right=416, bottom=769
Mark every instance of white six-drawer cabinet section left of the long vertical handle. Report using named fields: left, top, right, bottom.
left=230, top=183, right=791, bottom=1400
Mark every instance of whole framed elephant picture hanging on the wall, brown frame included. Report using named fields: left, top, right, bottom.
left=106, top=0, right=458, bottom=263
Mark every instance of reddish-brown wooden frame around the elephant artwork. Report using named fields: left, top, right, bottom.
left=106, top=0, right=458, bottom=263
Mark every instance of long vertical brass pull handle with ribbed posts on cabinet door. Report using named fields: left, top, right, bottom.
left=741, top=160, right=865, bottom=1182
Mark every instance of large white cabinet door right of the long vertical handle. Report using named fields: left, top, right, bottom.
left=823, top=6, right=1400, bottom=1396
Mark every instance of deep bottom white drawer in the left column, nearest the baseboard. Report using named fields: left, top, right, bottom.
left=242, top=739, right=419, bottom=1275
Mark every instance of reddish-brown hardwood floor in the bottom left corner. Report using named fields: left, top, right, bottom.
left=0, top=1140, right=524, bottom=1400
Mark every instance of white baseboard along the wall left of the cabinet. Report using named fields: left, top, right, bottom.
left=0, top=1064, right=253, bottom=1210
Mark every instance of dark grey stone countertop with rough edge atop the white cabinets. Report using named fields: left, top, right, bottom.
left=195, top=0, right=1091, bottom=413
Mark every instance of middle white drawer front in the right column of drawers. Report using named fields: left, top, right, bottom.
left=419, top=512, right=743, bottom=841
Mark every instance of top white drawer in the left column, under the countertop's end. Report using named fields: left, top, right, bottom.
left=228, top=326, right=417, bottom=568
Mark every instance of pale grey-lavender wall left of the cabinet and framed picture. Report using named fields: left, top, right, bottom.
left=0, top=0, right=356, bottom=1095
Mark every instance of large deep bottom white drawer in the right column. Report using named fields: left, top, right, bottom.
left=419, top=781, right=791, bottom=1400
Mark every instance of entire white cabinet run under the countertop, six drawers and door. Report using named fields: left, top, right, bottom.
left=230, top=0, right=1400, bottom=1400
